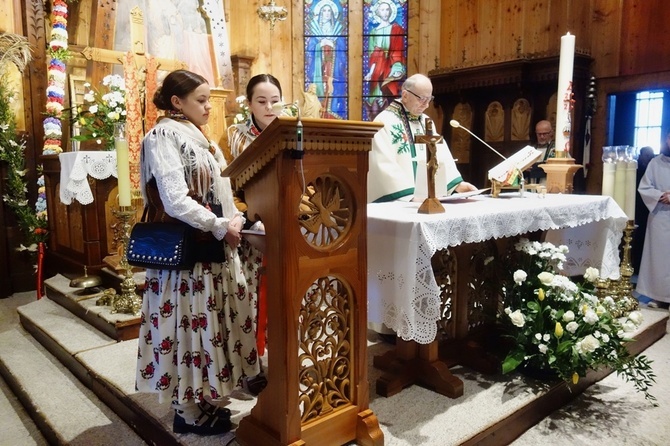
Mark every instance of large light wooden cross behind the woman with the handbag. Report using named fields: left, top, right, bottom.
left=81, top=6, right=188, bottom=193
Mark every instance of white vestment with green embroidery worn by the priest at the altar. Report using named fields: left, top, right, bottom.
left=368, top=100, right=463, bottom=203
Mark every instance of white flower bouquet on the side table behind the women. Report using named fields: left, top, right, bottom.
left=72, top=74, right=126, bottom=150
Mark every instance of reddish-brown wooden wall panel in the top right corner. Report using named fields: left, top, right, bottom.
left=619, top=0, right=670, bottom=75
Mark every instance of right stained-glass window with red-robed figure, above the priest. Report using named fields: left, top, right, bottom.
left=363, top=0, right=408, bottom=120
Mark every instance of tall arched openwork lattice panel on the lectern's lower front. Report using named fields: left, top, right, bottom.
left=298, top=276, right=353, bottom=424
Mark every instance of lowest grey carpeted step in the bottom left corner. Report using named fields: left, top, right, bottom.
left=0, top=329, right=145, bottom=446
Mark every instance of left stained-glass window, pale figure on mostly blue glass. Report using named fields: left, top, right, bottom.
left=303, top=0, right=349, bottom=119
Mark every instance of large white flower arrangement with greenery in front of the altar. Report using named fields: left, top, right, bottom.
left=499, top=239, right=656, bottom=402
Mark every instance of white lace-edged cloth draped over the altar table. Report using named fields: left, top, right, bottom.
left=367, top=192, right=627, bottom=344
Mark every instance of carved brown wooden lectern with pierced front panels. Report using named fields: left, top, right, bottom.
left=224, top=117, right=384, bottom=446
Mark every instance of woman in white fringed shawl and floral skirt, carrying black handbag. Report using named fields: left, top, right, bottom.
left=136, top=70, right=259, bottom=435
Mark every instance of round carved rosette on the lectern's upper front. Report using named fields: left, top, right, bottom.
left=298, top=175, right=354, bottom=251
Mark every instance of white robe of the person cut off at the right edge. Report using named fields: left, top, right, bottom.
left=635, top=155, right=670, bottom=302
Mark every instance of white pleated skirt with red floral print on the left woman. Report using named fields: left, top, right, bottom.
left=136, top=243, right=261, bottom=404
